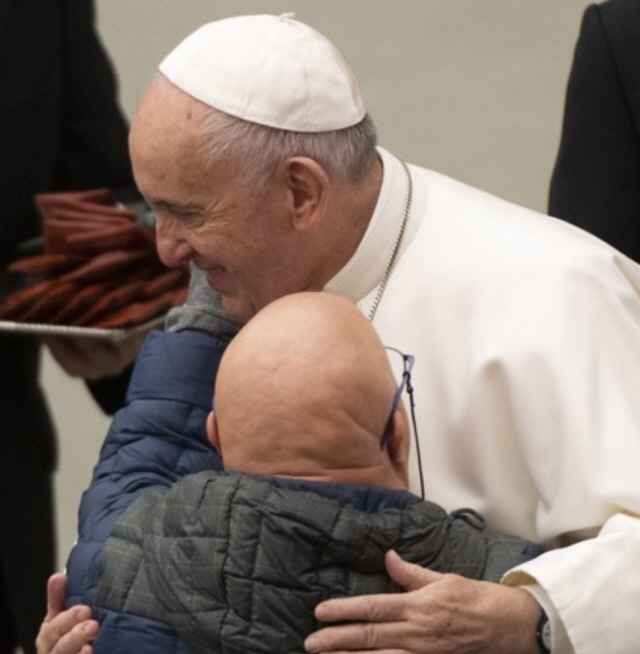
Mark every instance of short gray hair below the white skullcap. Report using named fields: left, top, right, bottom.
left=195, top=107, right=377, bottom=185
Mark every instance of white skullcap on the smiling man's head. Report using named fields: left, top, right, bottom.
left=160, top=14, right=365, bottom=132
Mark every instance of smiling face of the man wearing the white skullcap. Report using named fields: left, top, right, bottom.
left=130, top=80, right=316, bottom=321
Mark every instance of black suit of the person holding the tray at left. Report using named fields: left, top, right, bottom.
left=0, top=0, right=133, bottom=652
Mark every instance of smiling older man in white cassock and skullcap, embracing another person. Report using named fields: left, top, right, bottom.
left=38, top=10, right=640, bottom=654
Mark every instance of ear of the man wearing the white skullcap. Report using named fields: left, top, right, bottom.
left=285, top=157, right=329, bottom=231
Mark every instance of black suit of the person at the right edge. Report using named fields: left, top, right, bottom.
left=549, top=0, right=640, bottom=261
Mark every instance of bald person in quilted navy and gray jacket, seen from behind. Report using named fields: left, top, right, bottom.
left=60, top=293, right=541, bottom=654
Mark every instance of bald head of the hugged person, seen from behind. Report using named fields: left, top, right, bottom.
left=210, top=293, right=408, bottom=488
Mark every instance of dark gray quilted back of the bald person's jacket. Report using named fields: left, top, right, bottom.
left=95, top=472, right=540, bottom=654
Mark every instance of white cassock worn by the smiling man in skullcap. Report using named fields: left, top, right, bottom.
left=326, top=149, right=640, bottom=654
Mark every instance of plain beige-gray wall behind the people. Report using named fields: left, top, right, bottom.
left=43, top=0, right=589, bottom=565
